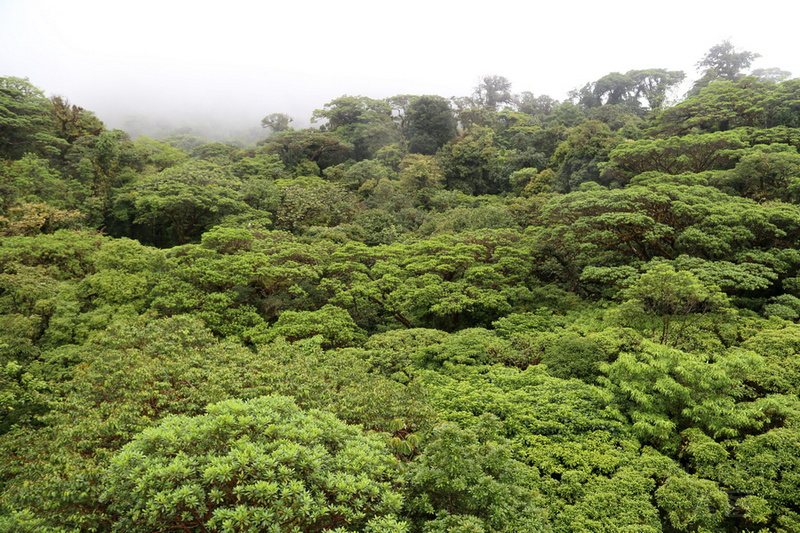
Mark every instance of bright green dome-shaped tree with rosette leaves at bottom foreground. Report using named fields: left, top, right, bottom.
left=102, top=396, right=402, bottom=533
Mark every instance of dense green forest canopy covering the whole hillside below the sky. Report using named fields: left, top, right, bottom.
left=0, top=43, right=800, bottom=533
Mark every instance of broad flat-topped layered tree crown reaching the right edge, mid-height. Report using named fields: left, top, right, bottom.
left=530, top=183, right=796, bottom=296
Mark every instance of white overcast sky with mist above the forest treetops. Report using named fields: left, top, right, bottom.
left=0, top=0, right=800, bottom=133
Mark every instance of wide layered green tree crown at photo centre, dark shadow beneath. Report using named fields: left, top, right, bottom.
left=327, top=230, right=530, bottom=330
